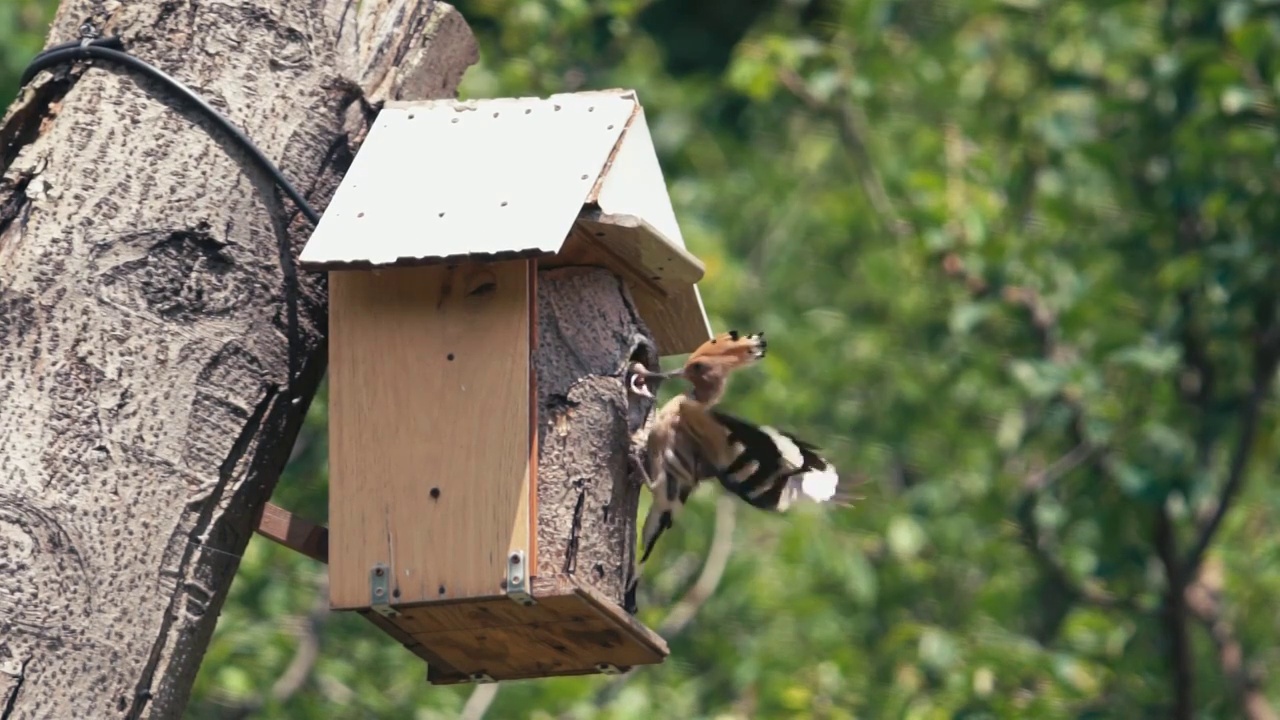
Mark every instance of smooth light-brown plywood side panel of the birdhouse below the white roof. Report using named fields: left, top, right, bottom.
left=329, top=260, right=530, bottom=609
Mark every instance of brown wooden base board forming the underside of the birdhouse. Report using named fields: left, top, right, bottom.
left=361, top=577, right=669, bottom=685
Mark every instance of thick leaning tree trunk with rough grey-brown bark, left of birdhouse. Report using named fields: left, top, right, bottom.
left=0, top=0, right=476, bottom=720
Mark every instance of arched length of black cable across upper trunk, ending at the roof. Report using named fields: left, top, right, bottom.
left=19, top=37, right=320, bottom=225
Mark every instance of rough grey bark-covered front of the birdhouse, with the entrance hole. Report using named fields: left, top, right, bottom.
left=534, top=268, right=658, bottom=605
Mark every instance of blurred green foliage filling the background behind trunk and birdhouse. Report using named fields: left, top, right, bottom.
left=0, top=0, right=1280, bottom=720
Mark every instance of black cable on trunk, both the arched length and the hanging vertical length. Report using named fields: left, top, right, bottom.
left=19, top=37, right=320, bottom=389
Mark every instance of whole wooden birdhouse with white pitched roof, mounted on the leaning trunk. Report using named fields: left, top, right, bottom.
left=301, top=90, right=710, bottom=683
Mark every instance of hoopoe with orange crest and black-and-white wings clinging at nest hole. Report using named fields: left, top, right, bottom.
left=625, top=331, right=842, bottom=612
